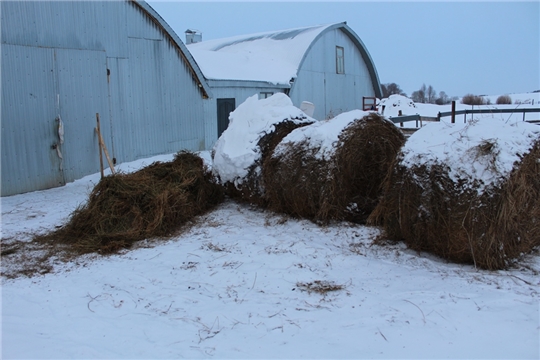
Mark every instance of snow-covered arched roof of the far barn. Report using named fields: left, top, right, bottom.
left=187, top=22, right=382, bottom=97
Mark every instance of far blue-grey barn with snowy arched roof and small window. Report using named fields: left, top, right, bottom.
left=187, top=22, right=382, bottom=135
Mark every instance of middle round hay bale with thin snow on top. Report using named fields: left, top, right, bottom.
left=264, top=110, right=405, bottom=223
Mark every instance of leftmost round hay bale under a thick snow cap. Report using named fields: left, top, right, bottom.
left=213, top=93, right=316, bottom=206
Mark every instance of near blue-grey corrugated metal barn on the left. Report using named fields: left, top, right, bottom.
left=0, top=0, right=215, bottom=196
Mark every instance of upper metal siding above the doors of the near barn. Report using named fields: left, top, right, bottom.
left=1, top=1, right=127, bottom=57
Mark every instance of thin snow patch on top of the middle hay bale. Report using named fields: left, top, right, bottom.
left=272, top=110, right=376, bottom=160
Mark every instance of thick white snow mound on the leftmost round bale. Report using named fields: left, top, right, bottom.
left=213, top=93, right=316, bottom=187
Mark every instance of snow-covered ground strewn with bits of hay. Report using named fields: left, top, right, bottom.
left=1, top=149, right=540, bottom=359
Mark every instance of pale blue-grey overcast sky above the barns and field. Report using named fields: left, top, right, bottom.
left=147, top=0, right=540, bottom=96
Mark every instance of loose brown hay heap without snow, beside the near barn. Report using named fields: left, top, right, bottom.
left=35, top=151, right=223, bottom=254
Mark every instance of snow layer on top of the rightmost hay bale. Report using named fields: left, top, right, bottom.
left=401, top=118, right=540, bottom=192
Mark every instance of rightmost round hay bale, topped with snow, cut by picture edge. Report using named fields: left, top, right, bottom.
left=368, top=119, right=540, bottom=270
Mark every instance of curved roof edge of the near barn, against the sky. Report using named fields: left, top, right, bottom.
left=130, top=0, right=212, bottom=98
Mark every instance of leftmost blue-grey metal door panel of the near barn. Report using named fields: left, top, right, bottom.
left=1, top=44, right=65, bottom=196
